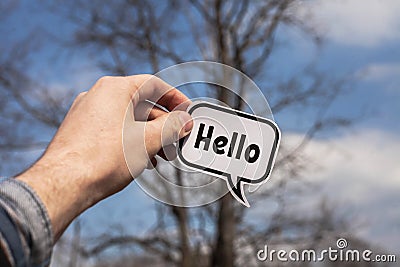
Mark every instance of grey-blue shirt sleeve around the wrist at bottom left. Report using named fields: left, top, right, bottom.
left=0, top=178, right=53, bottom=267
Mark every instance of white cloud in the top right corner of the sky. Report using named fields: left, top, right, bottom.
left=298, top=0, right=400, bottom=47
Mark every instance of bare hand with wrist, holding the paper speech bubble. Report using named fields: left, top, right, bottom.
left=17, top=75, right=193, bottom=240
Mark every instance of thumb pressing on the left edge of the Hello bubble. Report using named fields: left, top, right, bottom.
left=144, top=111, right=193, bottom=158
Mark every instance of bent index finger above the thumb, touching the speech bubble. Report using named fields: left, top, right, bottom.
left=131, top=75, right=191, bottom=111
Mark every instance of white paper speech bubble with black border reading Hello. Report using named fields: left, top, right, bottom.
left=177, top=102, right=281, bottom=207
